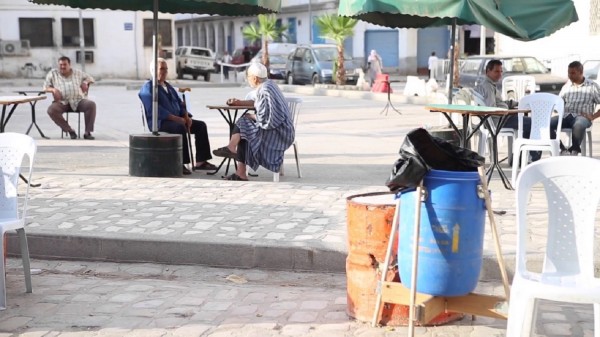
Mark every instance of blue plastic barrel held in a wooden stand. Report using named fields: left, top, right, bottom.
left=398, top=170, right=485, bottom=296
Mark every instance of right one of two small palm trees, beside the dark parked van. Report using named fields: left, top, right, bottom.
left=315, top=14, right=358, bottom=85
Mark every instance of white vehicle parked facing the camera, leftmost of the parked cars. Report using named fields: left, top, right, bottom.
left=175, top=46, right=215, bottom=82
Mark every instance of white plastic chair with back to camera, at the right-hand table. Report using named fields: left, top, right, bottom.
left=511, top=92, right=564, bottom=186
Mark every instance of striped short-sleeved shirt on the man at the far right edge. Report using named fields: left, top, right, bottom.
left=559, top=78, right=600, bottom=118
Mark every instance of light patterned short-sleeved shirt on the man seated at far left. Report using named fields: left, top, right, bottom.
left=44, top=68, right=94, bottom=111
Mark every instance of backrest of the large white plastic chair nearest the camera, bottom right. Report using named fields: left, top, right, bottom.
left=516, top=157, right=600, bottom=278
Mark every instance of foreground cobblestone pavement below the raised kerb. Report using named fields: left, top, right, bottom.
left=0, top=259, right=593, bottom=337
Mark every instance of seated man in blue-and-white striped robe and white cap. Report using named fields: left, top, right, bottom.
left=213, top=63, right=295, bottom=180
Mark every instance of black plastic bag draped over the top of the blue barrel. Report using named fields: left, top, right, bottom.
left=385, top=128, right=485, bottom=192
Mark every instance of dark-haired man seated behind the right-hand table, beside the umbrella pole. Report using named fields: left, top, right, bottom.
left=475, top=60, right=542, bottom=161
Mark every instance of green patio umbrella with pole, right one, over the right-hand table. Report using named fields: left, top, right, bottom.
left=338, top=0, right=578, bottom=103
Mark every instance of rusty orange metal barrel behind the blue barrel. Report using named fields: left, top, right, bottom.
left=346, top=192, right=463, bottom=326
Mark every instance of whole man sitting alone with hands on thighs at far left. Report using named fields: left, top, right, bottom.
left=44, top=56, right=96, bottom=140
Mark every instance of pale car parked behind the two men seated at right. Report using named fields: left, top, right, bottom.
left=458, top=55, right=567, bottom=94
